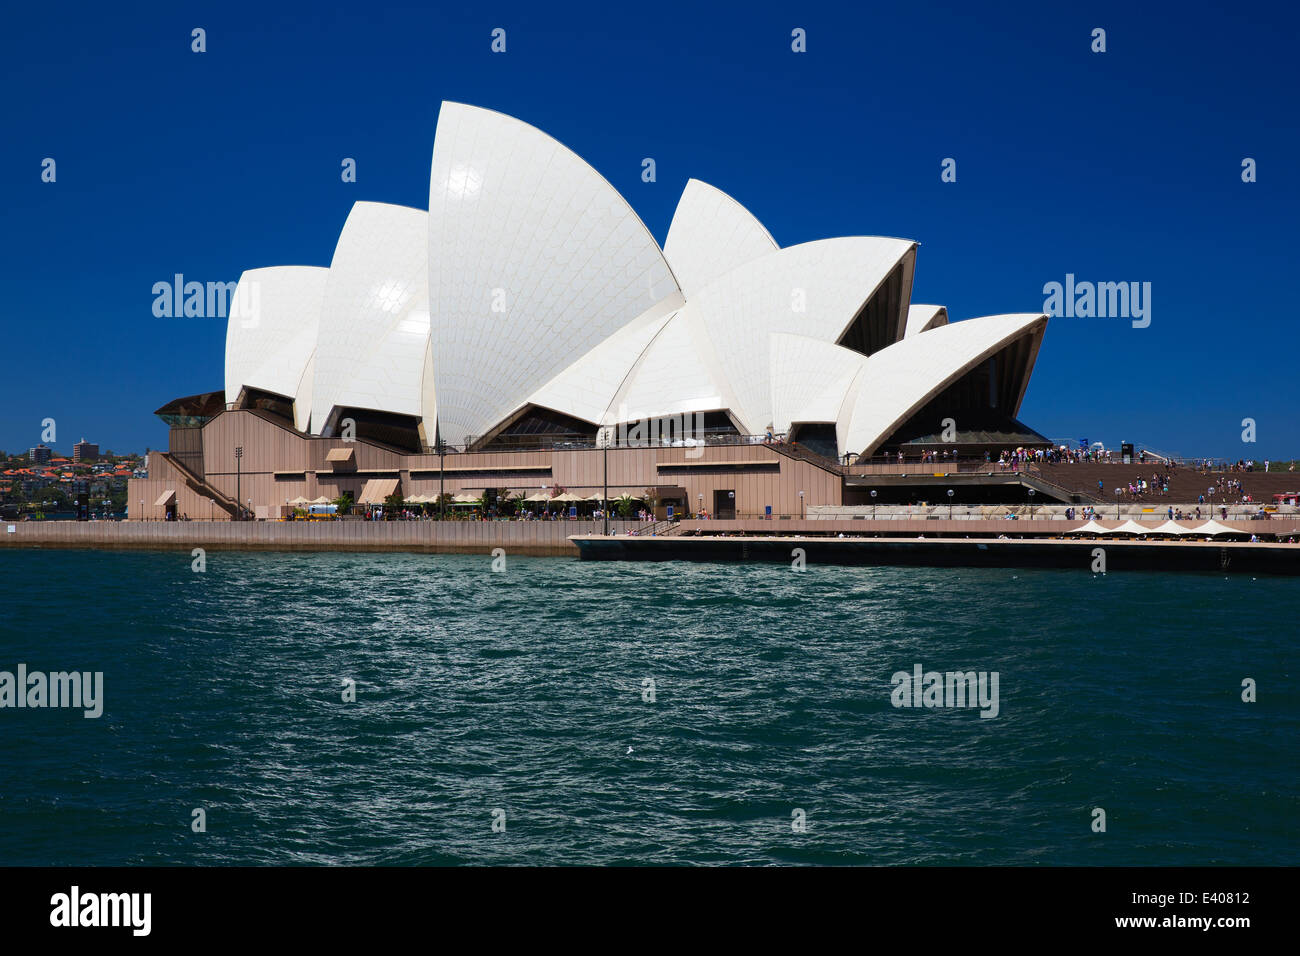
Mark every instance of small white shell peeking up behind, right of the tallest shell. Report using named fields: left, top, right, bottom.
left=663, top=179, right=780, bottom=298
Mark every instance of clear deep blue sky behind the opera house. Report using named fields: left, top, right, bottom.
left=0, top=3, right=1300, bottom=459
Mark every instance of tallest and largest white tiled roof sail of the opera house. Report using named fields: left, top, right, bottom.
left=428, top=103, right=680, bottom=442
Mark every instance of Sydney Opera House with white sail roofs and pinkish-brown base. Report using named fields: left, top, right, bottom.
left=130, top=103, right=1047, bottom=518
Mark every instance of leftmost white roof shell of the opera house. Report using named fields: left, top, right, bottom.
left=225, top=265, right=329, bottom=429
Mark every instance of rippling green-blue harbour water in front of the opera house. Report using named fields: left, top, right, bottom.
left=0, top=550, right=1300, bottom=865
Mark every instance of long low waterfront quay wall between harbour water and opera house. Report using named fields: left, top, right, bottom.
left=0, top=519, right=1300, bottom=575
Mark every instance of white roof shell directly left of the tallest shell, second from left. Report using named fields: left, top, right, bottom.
left=312, top=203, right=437, bottom=440
